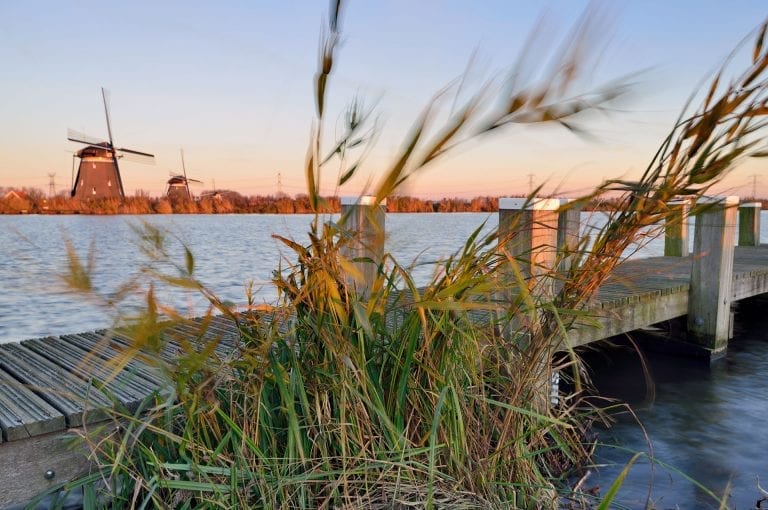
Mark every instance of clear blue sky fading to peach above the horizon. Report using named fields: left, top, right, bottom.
left=0, top=0, right=768, bottom=198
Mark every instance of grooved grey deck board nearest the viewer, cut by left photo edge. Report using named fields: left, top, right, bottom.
left=0, top=370, right=66, bottom=441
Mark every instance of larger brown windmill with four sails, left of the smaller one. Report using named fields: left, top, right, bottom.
left=67, top=87, right=155, bottom=199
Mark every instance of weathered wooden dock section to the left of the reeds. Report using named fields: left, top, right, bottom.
left=0, top=317, right=240, bottom=508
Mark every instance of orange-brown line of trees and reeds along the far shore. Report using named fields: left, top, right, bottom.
left=0, top=187, right=768, bottom=214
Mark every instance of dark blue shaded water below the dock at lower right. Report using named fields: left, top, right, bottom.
left=585, top=300, right=768, bottom=509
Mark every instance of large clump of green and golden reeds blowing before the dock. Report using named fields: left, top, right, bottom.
left=48, top=3, right=768, bottom=509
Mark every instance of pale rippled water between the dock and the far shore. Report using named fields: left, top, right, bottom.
left=0, top=214, right=504, bottom=343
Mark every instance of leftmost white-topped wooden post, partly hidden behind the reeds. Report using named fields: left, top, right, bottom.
left=340, top=195, right=387, bottom=295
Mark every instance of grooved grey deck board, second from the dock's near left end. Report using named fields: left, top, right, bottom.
left=0, top=343, right=112, bottom=427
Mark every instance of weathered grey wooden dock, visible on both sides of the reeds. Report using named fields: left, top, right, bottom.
left=0, top=197, right=768, bottom=508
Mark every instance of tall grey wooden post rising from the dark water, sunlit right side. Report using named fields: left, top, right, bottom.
left=688, top=196, right=739, bottom=359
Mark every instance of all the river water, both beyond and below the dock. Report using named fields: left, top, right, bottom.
left=0, top=212, right=768, bottom=509
